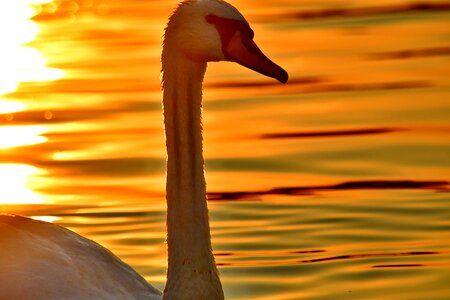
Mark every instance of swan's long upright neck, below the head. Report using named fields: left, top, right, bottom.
left=162, top=43, right=224, bottom=300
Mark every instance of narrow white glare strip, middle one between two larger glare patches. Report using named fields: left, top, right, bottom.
left=0, top=125, right=48, bottom=149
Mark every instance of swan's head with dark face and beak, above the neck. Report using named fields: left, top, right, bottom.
left=163, top=0, right=288, bottom=83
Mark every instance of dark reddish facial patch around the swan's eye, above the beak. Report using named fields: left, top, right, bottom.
left=205, top=14, right=255, bottom=55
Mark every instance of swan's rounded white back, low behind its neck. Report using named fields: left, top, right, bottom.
left=0, top=215, right=161, bottom=300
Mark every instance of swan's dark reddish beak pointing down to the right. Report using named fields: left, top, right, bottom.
left=224, top=30, right=289, bottom=83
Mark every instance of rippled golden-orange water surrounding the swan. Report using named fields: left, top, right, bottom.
left=0, top=0, right=450, bottom=300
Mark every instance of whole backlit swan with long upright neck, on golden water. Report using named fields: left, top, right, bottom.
left=0, top=0, right=288, bottom=300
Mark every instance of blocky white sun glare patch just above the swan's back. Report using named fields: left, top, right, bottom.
left=0, top=164, right=44, bottom=205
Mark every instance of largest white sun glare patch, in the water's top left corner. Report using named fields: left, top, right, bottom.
left=0, top=0, right=64, bottom=95
